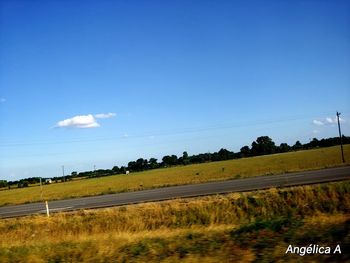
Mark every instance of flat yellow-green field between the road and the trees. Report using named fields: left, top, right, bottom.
left=0, top=145, right=350, bottom=206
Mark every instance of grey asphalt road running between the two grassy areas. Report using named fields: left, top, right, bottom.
left=0, top=166, right=350, bottom=218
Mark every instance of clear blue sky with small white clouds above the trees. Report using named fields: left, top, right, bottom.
left=0, top=0, right=350, bottom=180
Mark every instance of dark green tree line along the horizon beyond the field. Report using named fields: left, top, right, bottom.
left=0, top=136, right=350, bottom=188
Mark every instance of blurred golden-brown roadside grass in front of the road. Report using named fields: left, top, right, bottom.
left=0, top=181, right=350, bottom=262
